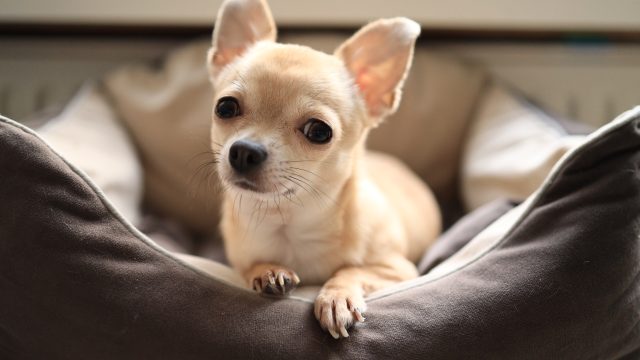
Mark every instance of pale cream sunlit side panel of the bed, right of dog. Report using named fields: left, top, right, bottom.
left=459, top=82, right=591, bottom=212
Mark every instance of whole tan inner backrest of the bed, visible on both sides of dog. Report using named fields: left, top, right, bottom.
left=104, top=38, right=487, bottom=234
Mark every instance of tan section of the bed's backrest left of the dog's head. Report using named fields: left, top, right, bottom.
left=103, top=43, right=219, bottom=234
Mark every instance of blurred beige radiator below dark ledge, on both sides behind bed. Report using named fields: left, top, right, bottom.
left=0, top=37, right=640, bottom=126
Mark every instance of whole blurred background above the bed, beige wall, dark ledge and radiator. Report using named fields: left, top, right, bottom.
left=0, top=0, right=640, bottom=125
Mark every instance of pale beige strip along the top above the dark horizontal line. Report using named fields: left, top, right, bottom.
left=0, top=0, right=640, bottom=31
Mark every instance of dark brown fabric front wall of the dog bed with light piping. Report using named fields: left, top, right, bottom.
left=0, top=100, right=640, bottom=359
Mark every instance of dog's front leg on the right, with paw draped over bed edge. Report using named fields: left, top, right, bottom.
left=314, top=256, right=418, bottom=339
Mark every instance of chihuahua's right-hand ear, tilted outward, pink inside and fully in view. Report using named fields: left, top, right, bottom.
left=335, top=18, right=420, bottom=123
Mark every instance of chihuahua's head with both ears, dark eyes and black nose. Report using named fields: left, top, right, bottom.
left=207, top=0, right=420, bottom=198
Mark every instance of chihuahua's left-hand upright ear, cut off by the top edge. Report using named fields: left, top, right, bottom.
left=207, top=0, right=277, bottom=79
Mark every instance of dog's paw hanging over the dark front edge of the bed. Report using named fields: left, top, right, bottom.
left=314, top=289, right=367, bottom=339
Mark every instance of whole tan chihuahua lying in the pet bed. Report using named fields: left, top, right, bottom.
left=208, top=0, right=440, bottom=338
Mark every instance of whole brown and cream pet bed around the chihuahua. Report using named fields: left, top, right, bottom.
left=0, top=39, right=640, bottom=359
